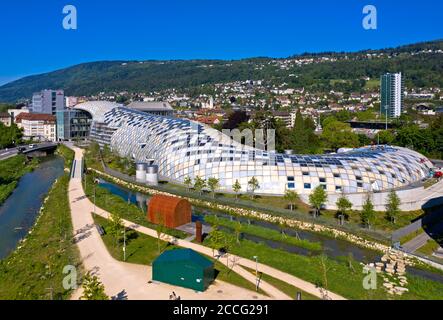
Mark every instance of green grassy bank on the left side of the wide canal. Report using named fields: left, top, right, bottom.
left=0, top=155, right=39, bottom=205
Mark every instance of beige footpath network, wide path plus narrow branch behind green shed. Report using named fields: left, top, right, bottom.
left=69, top=146, right=345, bottom=300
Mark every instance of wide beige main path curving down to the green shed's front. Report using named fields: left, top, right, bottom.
left=69, top=148, right=269, bottom=300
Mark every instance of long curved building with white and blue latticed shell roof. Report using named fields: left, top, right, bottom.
left=75, top=102, right=432, bottom=195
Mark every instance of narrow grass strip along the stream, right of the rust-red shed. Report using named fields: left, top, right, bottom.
left=205, top=215, right=322, bottom=251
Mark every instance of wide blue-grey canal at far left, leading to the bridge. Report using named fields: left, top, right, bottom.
left=0, top=156, right=64, bottom=259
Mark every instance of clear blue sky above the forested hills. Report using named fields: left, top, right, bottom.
left=0, top=0, right=443, bottom=84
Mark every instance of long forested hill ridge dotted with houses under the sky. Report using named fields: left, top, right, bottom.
left=0, top=40, right=443, bottom=102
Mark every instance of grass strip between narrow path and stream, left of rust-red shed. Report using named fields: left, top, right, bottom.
left=83, top=174, right=189, bottom=239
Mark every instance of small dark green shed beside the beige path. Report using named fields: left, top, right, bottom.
left=152, top=249, right=214, bottom=291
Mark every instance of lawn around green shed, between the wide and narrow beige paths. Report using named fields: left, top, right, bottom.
left=94, top=216, right=264, bottom=294
